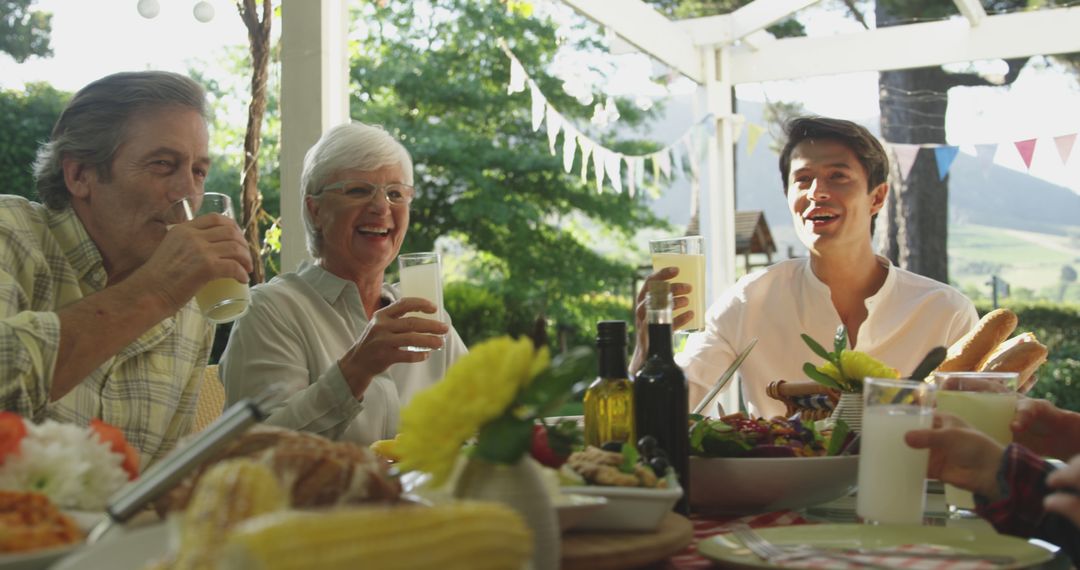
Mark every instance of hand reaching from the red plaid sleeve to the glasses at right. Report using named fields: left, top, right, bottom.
left=904, top=412, right=1004, bottom=501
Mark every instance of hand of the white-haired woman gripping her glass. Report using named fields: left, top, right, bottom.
left=338, top=297, right=450, bottom=398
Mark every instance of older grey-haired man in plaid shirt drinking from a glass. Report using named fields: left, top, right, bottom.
left=0, top=71, right=252, bottom=464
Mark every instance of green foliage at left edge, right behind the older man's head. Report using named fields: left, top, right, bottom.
left=0, top=83, right=71, bottom=200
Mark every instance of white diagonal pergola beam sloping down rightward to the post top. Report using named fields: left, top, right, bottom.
left=563, top=0, right=703, bottom=83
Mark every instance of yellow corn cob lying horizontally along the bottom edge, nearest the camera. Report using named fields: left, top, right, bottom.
left=218, top=502, right=532, bottom=570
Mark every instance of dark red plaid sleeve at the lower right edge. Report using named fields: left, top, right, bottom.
left=975, top=444, right=1054, bottom=537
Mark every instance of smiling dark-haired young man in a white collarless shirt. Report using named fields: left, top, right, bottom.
left=635, top=118, right=977, bottom=417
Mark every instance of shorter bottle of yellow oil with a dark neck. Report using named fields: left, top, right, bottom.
left=584, top=321, right=635, bottom=447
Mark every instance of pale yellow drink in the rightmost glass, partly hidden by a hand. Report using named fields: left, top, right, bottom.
left=937, top=390, right=1016, bottom=511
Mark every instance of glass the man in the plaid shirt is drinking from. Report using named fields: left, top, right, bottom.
left=170, top=192, right=252, bottom=324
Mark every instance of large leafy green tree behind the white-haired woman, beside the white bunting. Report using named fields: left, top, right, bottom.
left=351, top=0, right=663, bottom=342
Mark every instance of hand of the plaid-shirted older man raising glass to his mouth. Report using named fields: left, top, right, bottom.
left=133, top=214, right=254, bottom=313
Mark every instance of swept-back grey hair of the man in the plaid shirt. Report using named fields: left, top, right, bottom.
left=33, top=71, right=208, bottom=209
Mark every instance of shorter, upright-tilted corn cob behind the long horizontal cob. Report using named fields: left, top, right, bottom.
left=171, top=459, right=288, bottom=570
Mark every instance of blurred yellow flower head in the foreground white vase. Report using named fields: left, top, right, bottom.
left=395, top=337, right=550, bottom=485
